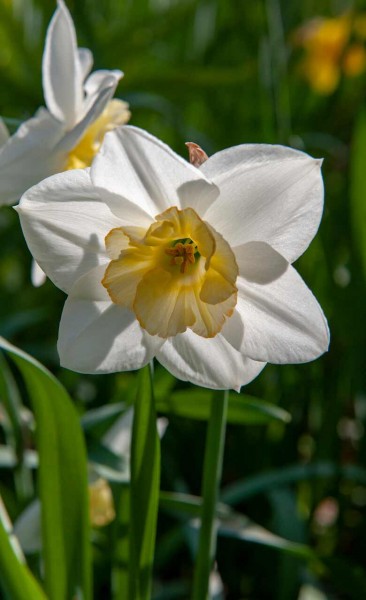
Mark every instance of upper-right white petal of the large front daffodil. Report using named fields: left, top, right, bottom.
left=201, top=145, right=323, bottom=262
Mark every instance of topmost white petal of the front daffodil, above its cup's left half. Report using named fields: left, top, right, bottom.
left=91, top=126, right=218, bottom=217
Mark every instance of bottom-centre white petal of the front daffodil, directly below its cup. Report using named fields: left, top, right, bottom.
left=156, top=330, right=265, bottom=391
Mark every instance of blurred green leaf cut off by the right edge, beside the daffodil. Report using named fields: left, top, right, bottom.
left=350, top=110, right=366, bottom=276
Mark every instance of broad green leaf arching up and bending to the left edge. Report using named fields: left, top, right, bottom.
left=0, top=338, right=91, bottom=600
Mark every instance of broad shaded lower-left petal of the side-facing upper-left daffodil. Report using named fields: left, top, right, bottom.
left=0, top=110, right=66, bottom=204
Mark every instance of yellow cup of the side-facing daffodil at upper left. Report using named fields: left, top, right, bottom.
left=65, top=98, right=130, bottom=171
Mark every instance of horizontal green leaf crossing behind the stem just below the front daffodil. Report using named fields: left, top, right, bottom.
left=156, top=388, right=291, bottom=425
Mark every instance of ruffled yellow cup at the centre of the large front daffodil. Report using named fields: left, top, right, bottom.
left=102, top=206, right=238, bottom=338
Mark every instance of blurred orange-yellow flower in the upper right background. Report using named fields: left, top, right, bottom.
left=295, top=13, right=366, bottom=95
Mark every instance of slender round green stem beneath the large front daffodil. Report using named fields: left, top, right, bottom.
left=192, top=391, right=229, bottom=600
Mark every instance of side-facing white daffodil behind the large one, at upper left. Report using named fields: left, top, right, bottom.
left=0, top=0, right=130, bottom=204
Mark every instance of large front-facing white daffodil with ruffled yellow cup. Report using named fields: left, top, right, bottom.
left=18, top=126, right=329, bottom=390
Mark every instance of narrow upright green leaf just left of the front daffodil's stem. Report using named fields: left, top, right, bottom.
left=129, top=366, right=160, bottom=600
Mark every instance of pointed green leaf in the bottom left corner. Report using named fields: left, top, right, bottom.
left=0, top=496, right=46, bottom=600
